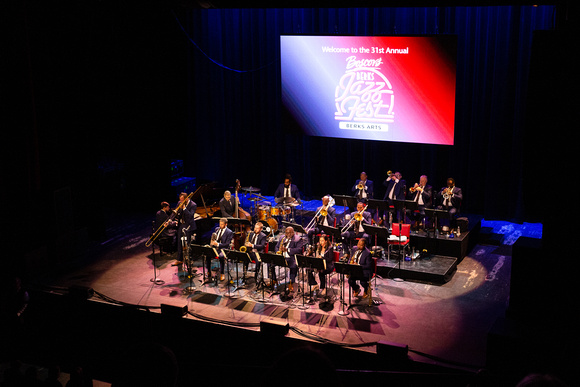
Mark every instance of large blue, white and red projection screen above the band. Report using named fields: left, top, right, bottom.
left=280, top=35, right=457, bottom=145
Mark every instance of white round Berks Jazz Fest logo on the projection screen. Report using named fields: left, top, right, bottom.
left=334, top=55, right=394, bottom=131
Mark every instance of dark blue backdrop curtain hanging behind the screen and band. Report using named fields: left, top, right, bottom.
left=184, top=6, right=555, bottom=221
